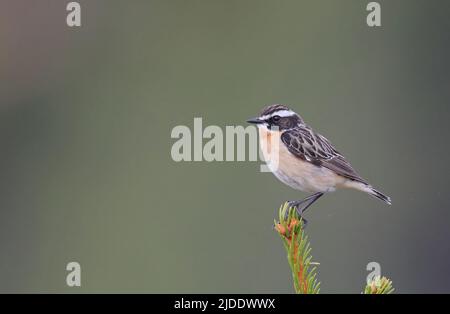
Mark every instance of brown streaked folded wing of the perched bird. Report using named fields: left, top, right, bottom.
left=281, top=127, right=367, bottom=184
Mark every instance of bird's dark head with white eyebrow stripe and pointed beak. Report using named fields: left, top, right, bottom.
left=247, top=104, right=304, bottom=131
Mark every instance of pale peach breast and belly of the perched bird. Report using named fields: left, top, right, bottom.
left=259, top=128, right=347, bottom=193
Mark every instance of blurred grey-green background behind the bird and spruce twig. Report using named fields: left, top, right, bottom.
left=0, top=0, right=450, bottom=293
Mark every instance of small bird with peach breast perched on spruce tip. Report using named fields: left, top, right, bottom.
left=247, top=104, right=391, bottom=216
